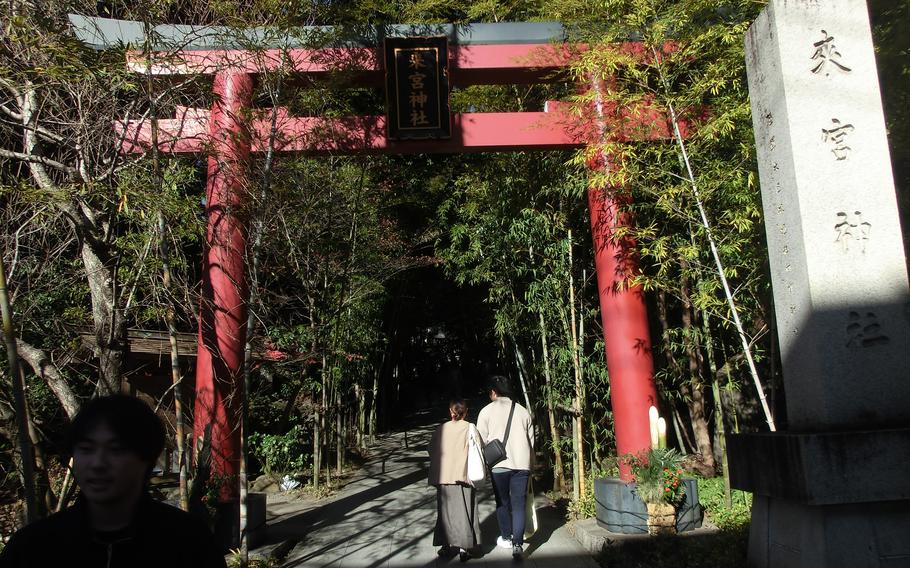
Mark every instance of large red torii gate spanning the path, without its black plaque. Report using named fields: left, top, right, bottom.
left=71, top=17, right=684, bottom=498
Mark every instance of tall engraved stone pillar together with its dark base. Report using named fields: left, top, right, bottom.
left=729, top=0, right=910, bottom=568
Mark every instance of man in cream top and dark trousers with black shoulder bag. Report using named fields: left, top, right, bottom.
left=477, top=375, right=534, bottom=558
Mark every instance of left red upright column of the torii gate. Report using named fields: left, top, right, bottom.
left=193, top=72, right=253, bottom=500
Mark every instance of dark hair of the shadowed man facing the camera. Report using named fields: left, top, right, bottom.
left=66, top=394, right=165, bottom=473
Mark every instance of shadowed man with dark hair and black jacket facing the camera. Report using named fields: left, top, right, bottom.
left=0, top=395, right=226, bottom=568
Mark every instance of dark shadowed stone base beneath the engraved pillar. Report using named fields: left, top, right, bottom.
left=727, top=428, right=910, bottom=568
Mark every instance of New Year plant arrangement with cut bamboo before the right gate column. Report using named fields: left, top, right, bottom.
left=626, top=448, right=685, bottom=535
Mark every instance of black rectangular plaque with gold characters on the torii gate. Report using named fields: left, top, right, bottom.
left=385, top=37, right=452, bottom=140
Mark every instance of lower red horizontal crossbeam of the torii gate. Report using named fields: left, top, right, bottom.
left=118, top=101, right=688, bottom=154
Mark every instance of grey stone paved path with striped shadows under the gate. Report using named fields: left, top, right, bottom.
left=254, top=412, right=597, bottom=568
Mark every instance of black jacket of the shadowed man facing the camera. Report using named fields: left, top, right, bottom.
left=0, top=497, right=226, bottom=568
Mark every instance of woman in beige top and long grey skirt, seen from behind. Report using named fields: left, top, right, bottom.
left=429, top=400, right=482, bottom=562
